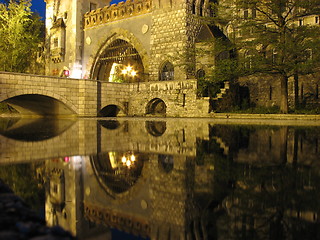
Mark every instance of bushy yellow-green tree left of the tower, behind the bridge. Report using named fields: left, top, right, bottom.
left=0, top=0, right=43, bottom=72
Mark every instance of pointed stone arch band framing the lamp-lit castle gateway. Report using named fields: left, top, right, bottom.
left=88, top=28, right=149, bottom=79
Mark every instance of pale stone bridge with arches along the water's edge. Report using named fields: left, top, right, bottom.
left=0, top=72, right=209, bottom=117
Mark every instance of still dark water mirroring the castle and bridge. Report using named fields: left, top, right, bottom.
left=0, top=118, right=320, bottom=240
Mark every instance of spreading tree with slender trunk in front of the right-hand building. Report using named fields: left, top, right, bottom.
left=212, top=0, right=320, bottom=113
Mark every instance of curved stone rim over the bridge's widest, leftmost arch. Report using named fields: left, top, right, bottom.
left=0, top=87, right=79, bottom=114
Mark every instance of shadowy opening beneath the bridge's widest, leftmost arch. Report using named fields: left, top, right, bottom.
left=3, top=94, right=75, bottom=116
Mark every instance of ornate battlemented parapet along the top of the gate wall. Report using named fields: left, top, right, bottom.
left=84, top=0, right=152, bottom=28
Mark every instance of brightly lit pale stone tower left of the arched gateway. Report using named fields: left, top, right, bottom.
left=45, top=0, right=110, bottom=78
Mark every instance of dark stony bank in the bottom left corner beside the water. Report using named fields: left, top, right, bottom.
left=0, top=179, right=75, bottom=240
